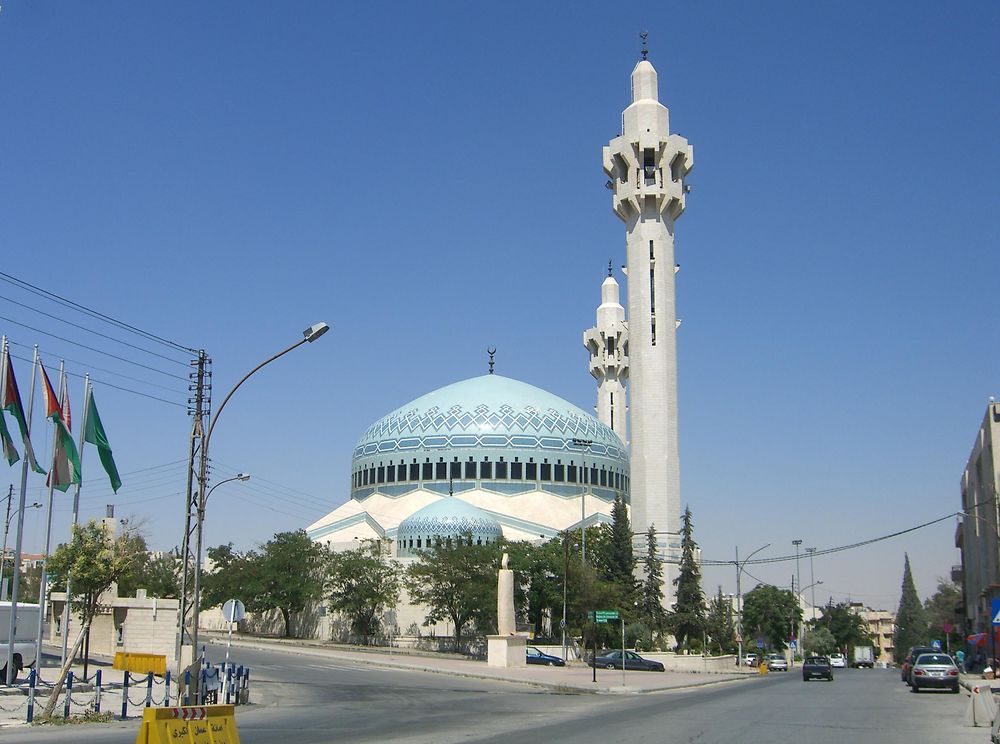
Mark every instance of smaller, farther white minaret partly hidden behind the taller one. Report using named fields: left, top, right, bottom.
left=583, top=262, right=628, bottom=442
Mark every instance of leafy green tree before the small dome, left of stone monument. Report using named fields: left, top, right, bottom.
left=404, top=534, right=502, bottom=651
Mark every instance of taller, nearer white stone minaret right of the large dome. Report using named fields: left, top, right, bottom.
left=604, top=48, right=694, bottom=605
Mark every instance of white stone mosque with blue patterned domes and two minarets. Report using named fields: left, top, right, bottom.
left=306, top=49, right=693, bottom=636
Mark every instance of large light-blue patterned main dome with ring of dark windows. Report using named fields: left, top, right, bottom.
left=351, top=375, right=629, bottom=500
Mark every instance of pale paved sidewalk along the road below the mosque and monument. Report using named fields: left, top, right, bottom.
left=202, top=631, right=757, bottom=695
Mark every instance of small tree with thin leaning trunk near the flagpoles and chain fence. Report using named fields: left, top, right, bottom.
left=44, top=519, right=145, bottom=716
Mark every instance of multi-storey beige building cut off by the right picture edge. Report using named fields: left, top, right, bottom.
left=952, top=400, right=1000, bottom=633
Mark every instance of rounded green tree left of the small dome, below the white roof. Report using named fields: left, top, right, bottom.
left=326, top=540, right=401, bottom=639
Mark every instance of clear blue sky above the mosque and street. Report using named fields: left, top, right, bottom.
left=0, top=0, right=1000, bottom=609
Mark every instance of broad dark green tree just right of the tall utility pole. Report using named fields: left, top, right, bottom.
left=201, top=530, right=325, bottom=638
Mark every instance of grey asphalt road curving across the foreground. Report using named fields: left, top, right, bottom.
left=0, top=647, right=989, bottom=744
